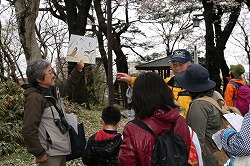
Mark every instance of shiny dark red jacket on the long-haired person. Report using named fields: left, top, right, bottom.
left=118, top=109, right=190, bottom=166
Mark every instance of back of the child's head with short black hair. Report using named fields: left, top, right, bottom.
left=102, top=106, right=121, bottom=126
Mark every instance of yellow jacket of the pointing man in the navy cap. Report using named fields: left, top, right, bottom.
left=130, top=77, right=192, bottom=118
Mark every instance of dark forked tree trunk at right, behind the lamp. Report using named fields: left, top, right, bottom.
left=202, top=0, right=241, bottom=92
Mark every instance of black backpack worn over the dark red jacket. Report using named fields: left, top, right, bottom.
left=131, top=119, right=190, bottom=166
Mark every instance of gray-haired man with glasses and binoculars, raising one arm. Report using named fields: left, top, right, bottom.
left=22, top=59, right=84, bottom=166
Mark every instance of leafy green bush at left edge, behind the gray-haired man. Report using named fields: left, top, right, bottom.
left=0, top=81, right=24, bottom=156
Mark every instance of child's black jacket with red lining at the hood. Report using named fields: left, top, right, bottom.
left=82, top=130, right=122, bottom=166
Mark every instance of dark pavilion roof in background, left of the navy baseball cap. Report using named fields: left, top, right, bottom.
left=135, top=57, right=171, bottom=78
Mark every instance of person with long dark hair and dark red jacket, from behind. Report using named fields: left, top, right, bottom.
left=118, top=72, right=190, bottom=166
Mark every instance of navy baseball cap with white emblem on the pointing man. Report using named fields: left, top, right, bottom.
left=170, top=49, right=193, bottom=63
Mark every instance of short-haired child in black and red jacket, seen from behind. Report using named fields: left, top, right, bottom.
left=82, top=106, right=122, bottom=166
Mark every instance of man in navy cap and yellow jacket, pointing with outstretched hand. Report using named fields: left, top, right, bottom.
left=116, top=49, right=193, bottom=118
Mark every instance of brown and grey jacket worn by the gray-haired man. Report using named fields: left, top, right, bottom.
left=22, top=69, right=82, bottom=158
